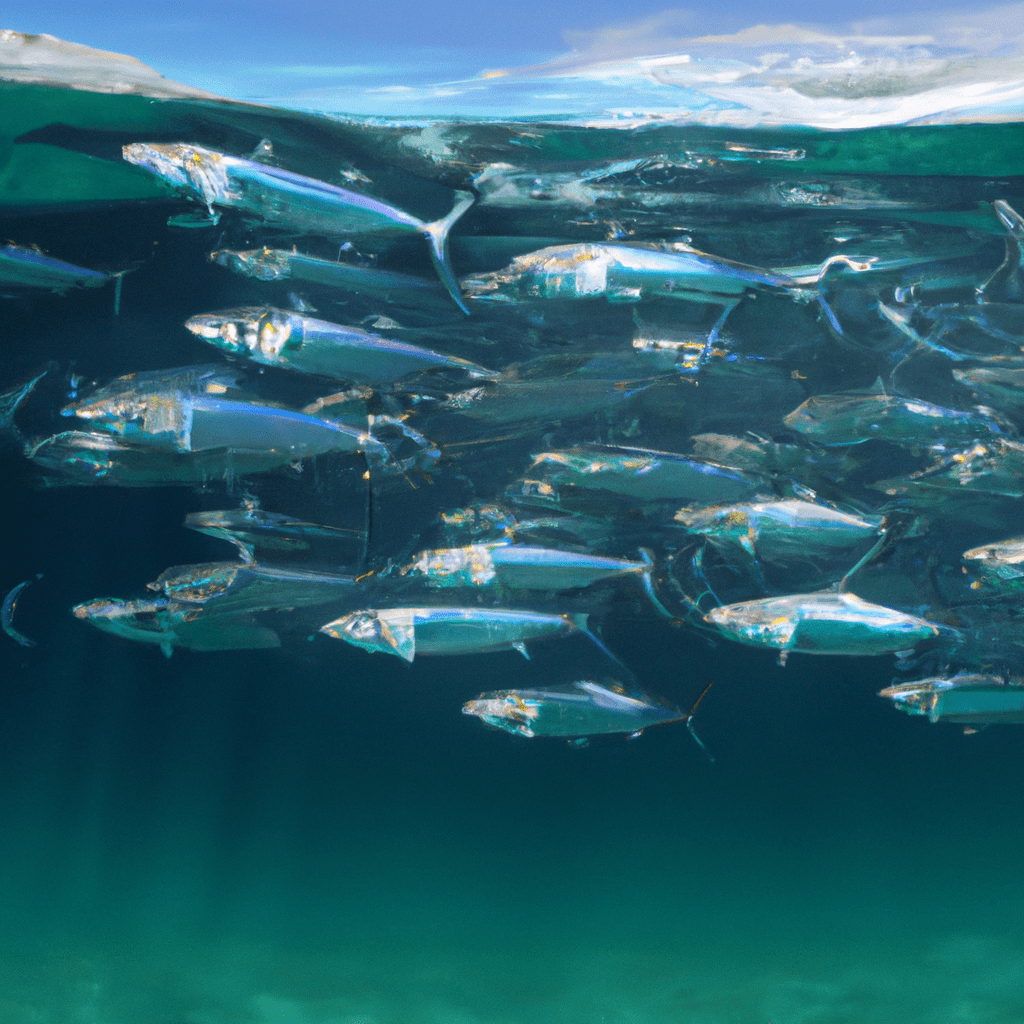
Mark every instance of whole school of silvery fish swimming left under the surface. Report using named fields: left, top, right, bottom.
left=6, top=117, right=1024, bottom=743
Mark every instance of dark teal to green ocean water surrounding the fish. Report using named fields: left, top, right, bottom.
left=0, top=24, right=1024, bottom=1024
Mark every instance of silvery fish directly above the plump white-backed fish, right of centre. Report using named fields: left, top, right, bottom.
left=675, top=499, right=885, bottom=562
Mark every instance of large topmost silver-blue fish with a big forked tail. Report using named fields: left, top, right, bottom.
left=122, top=142, right=474, bottom=313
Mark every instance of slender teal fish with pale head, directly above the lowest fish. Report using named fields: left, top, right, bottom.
left=321, top=607, right=589, bottom=662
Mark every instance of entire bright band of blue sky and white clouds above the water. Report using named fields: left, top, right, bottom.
left=8, top=0, right=1024, bottom=121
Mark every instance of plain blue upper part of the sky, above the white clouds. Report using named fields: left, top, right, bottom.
left=0, top=0, right=987, bottom=71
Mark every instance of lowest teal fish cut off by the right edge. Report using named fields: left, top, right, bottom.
left=879, top=673, right=1024, bottom=731
